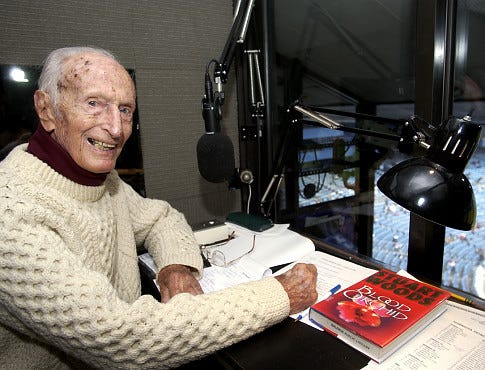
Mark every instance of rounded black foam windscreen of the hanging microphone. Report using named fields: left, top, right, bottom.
left=197, top=132, right=235, bottom=183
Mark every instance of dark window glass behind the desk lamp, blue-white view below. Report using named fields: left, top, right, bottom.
left=267, top=0, right=485, bottom=298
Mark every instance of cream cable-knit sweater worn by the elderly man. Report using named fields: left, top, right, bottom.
left=0, top=145, right=289, bottom=369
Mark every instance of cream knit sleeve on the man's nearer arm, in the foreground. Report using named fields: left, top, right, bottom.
left=0, top=205, right=289, bottom=369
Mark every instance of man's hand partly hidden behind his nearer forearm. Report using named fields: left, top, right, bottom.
left=157, top=265, right=200, bottom=303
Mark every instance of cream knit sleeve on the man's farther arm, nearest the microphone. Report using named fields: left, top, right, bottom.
left=109, top=174, right=202, bottom=274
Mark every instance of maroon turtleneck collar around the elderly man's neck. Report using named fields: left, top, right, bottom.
left=27, top=124, right=108, bottom=186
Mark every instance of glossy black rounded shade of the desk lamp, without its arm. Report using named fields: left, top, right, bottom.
left=377, top=118, right=481, bottom=230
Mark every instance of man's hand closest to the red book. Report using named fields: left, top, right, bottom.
left=275, top=263, right=318, bottom=315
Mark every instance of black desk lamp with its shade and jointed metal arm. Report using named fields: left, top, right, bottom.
left=292, top=104, right=481, bottom=230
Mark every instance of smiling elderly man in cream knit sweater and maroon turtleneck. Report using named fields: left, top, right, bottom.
left=0, top=48, right=317, bottom=369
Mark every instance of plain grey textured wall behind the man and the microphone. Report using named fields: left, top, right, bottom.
left=0, top=0, right=240, bottom=223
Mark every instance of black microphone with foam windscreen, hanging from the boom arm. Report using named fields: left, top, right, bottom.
left=197, top=72, right=235, bottom=183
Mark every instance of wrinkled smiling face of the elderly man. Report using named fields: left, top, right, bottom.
left=52, top=54, right=135, bottom=173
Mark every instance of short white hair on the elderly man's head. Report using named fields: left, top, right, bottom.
left=38, top=46, right=117, bottom=114
